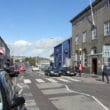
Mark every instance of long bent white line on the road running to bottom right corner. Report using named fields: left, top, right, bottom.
left=65, top=85, right=109, bottom=110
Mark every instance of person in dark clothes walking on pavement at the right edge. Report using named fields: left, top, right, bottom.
left=102, top=64, right=109, bottom=83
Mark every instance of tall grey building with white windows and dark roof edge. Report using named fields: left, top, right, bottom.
left=70, top=0, right=110, bottom=74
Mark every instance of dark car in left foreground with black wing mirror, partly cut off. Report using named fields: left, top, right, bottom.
left=0, top=70, right=26, bottom=110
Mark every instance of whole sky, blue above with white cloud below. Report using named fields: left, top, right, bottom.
left=0, top=0, right=93, bottom=57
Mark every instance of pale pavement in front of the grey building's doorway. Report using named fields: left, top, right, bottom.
left=74, top=73, right=110, bottom=84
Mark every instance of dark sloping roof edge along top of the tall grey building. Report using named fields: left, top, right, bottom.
left=70, top=0, right=102, bottom=23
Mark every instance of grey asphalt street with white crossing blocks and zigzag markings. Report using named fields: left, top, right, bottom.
left=17, top=70, right=110, bottom=110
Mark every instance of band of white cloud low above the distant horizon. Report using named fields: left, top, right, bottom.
left=7, top=38, right=63, bottom=58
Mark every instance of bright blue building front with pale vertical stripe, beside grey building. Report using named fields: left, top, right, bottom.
left=54, top=39, right=71, bottom=67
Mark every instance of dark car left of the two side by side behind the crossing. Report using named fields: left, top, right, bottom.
left=45, top=67, right=61, bottom=76
